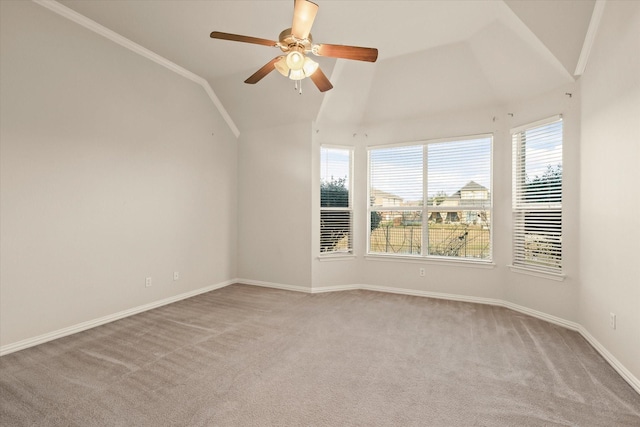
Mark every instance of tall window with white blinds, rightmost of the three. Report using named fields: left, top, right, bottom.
left=511, top=116, right=562, bottom=273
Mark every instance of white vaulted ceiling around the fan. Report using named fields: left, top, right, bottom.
left=60, top=0, right=595, bottom=132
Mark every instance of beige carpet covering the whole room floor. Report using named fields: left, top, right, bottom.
left=0, top=285, right=640, bottom=427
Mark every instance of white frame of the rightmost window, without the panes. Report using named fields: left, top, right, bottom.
left=509, top=114, right=565, bottom=281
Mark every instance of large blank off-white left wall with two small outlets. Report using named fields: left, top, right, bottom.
left=0, top=1, right=237, bottom=346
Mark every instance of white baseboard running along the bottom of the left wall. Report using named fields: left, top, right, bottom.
left=0, top=280, right=236, bottom=356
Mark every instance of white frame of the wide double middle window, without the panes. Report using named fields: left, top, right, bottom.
left=366, top=133, right=495, bottom=268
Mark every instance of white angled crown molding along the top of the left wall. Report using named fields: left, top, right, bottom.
left=33, top=0, right=240, bottom=138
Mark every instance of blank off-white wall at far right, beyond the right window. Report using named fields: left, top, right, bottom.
left=580, top=1, right=640, bottom=384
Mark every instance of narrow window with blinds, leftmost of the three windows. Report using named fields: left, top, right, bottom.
left=320, top=146, right=353, bottom=255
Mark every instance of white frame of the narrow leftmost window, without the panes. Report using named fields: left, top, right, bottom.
left=316, top=144, right=355, bottom=260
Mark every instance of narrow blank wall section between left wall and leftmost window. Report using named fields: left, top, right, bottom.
left=238, top=124, right=311, bottom=290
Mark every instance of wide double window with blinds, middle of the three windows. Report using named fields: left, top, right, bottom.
left=368, top=135, right=493, bottom=261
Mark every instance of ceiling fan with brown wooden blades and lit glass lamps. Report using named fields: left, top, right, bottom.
left=211, top=0, right=378, bottom=93
